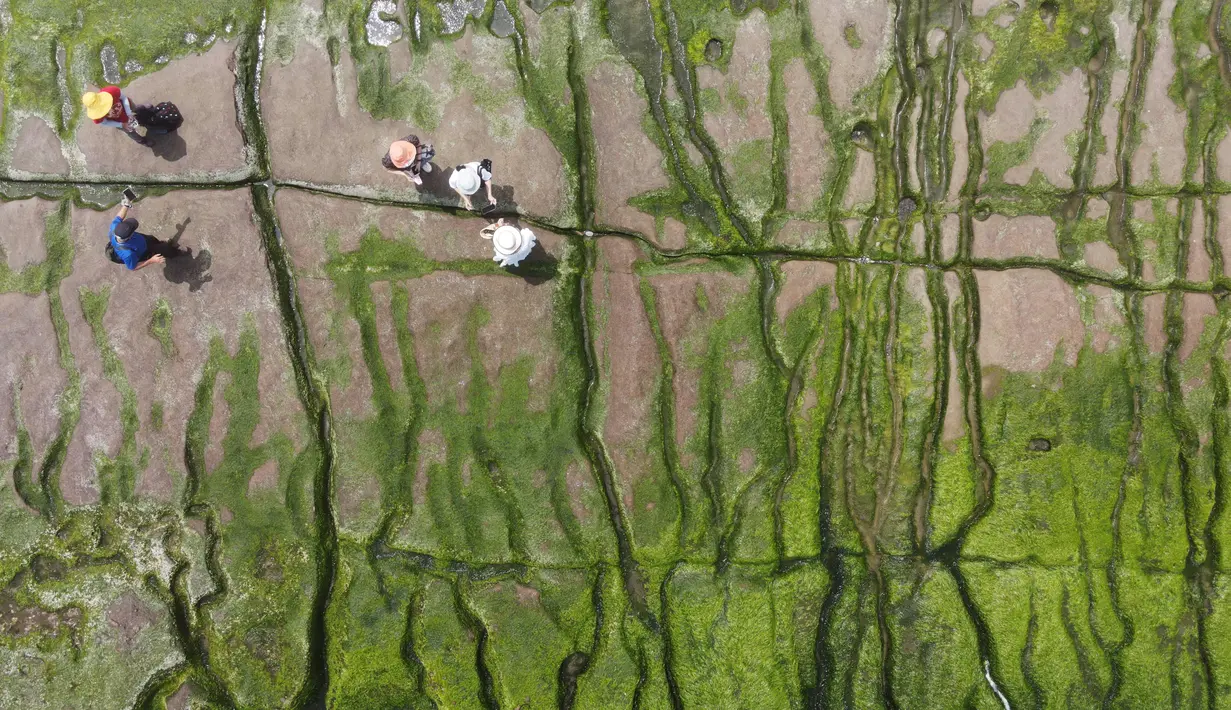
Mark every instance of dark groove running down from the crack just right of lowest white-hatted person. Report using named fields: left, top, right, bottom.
left=574, top=240, right=659, bottom=630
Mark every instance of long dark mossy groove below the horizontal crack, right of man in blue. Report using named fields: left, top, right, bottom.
left=251, top=185, right=339, bottom=709
